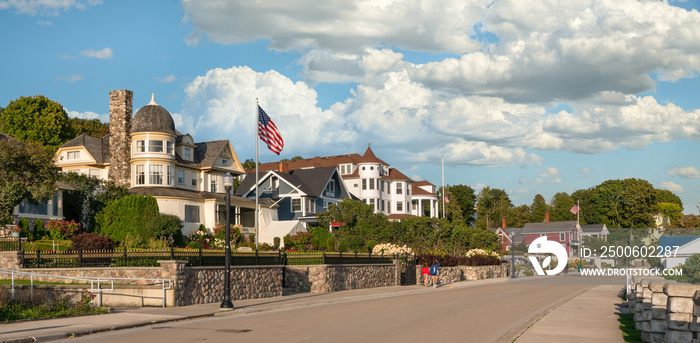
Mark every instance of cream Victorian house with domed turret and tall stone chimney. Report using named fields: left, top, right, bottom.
left=56, top=90, right=276, bottom=234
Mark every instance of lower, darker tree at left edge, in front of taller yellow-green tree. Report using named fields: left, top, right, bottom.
left=0, top=139, right=58, bottom=224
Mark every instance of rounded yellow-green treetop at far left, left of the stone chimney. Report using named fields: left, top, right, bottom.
left=0, top=95, right=72, bottom=154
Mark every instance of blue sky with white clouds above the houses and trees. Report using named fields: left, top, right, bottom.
left=0, top=0, right=700, bottom=214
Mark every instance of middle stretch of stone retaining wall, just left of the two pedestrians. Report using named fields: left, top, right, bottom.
left=284, top=264, right=400, bottom=292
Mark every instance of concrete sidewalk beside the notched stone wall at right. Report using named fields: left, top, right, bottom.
left=515, top=285, right=624, bottom=343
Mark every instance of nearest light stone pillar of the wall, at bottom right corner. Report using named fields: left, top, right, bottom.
left=664, top=283, right=700, bottom=343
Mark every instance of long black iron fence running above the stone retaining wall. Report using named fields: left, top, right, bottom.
left=20, top=248, right=406, bottom=268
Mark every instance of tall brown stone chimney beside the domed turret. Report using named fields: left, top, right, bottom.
left=109, top=89, right=134, bottom=188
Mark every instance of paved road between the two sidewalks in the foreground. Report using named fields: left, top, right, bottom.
left=58, top=283, right=608, bottom=343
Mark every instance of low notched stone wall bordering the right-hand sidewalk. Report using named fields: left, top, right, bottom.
left=627, top=277, right=700, bottom=343
